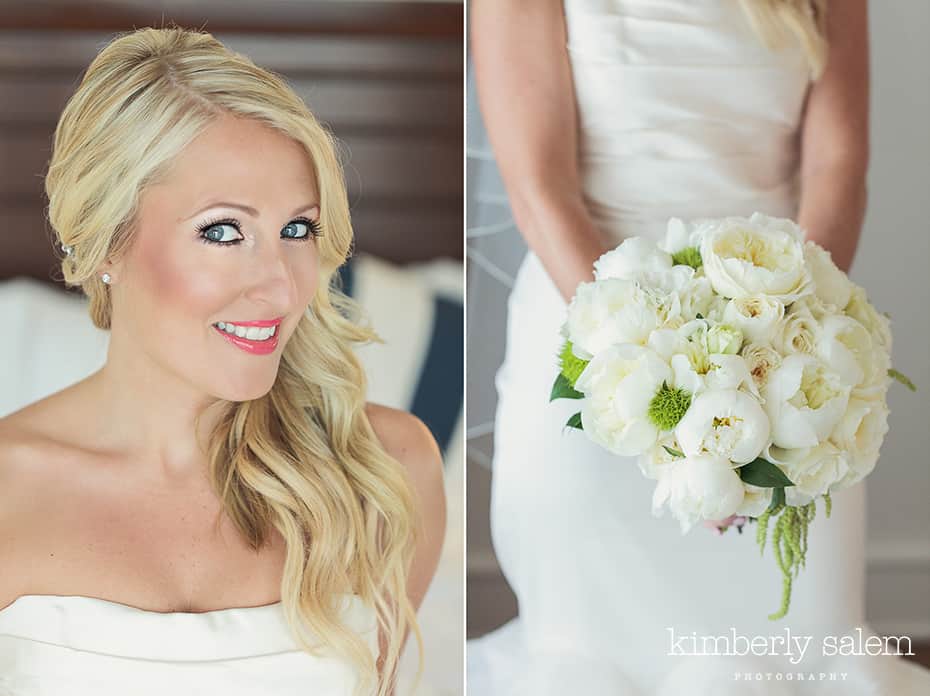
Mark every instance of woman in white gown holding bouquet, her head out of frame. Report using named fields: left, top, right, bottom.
left=467, top=0, right=930, bottom=696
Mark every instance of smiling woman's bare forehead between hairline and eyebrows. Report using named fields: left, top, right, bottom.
left=150, top=116, right=318, bottom=212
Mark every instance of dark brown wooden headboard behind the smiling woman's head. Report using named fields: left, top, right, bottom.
left=0, top=0, right=463, bottom=282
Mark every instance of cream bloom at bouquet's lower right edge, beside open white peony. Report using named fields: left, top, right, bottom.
left=830, top=398, right=888, bottom=489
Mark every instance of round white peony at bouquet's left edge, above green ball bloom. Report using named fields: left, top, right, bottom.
left=566, top=278, right=660, bottom=359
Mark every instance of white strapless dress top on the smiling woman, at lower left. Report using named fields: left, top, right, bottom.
left=0, top=595, right=378, bottom=696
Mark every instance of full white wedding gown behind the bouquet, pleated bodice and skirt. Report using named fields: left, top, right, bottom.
left=467, top=0, right=930, bottom=696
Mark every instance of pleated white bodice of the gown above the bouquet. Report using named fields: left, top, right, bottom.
left=564, top=0, right=810, bottom=240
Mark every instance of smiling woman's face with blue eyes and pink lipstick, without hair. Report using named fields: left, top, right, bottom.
left=111, top=116, right=325, bottom=401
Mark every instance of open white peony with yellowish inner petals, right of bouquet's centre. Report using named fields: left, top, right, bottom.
left=762, top=353, right=850, bottom=449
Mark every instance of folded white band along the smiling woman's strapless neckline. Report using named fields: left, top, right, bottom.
left=0, top=593, right=377, bottom=662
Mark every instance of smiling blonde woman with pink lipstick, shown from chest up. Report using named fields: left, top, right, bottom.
left=0, top=28, right=445, bottom=696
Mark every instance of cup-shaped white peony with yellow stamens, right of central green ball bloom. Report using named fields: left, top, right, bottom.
left=675, top=389, right=769, bottom=464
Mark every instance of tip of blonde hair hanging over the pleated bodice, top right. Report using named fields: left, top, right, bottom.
left=740, top=0, right=829, bottom=80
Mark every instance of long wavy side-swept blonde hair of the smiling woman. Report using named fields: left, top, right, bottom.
left=45, top=27, right=423, bottom=696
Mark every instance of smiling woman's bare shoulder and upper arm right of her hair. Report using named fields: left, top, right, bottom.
left=365, top=403, right=446, bottom=608
